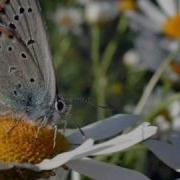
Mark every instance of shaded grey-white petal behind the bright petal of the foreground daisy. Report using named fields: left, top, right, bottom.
left=67, top=114, right=139, bottom=144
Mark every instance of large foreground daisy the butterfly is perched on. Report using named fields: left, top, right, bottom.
left=0, top=115, right=157, bottom=180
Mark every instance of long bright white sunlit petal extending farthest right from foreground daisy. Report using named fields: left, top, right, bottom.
left=93, top=123, right=157, bottom=155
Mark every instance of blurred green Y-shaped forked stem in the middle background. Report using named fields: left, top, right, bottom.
left=91, top=18, right=127, bottom=120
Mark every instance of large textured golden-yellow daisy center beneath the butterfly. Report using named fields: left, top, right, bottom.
left=0, top=114, right=70, bottom=164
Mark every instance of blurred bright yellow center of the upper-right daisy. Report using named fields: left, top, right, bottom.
left=163, top=14, right=180, bottom=39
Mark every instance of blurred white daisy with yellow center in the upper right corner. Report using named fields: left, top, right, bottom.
left=126, top=0, right=180, bottom=51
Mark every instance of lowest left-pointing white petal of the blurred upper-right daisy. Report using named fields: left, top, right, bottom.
left=125, top=12, right=161, bottom=33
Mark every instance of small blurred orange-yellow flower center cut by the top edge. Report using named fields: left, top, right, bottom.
left=119, top=0, right=137, bottom=12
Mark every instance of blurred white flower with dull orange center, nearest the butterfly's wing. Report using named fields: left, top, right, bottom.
left=55, top=7, right=84, bottom=34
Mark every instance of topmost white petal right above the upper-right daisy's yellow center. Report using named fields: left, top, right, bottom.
left=157, top=0, right=177, bottom=16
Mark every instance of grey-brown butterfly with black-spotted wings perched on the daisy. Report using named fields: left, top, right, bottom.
left=0, top=0, right=66, bottom=126
